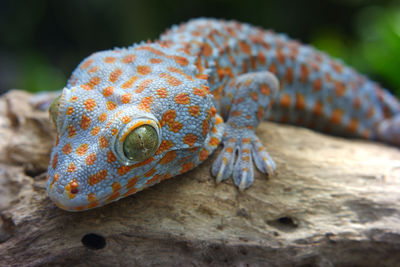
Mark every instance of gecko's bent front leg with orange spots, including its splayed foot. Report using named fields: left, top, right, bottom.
left=212, top=71, right=279, bottom=190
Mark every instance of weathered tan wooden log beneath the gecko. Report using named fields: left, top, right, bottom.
left=0, top=91, right=400, bottom=266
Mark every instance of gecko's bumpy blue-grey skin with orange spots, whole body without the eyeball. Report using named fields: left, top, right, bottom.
left=47, top=19, right=400, bottom=211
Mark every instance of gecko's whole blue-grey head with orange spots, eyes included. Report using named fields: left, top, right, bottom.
left=47, top=48, right=222, bottom=211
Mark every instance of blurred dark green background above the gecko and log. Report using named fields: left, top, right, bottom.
left=0, top=0, right=400, bottom=96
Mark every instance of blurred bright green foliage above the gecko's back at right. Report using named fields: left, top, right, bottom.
left=312, top=6, right=400, bottom=97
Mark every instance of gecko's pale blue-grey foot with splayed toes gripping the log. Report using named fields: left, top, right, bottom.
left=211, top=126, right=275, bottom=190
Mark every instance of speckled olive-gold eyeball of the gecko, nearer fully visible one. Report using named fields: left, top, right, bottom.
left=123, top=125, right=158, bottom=161
